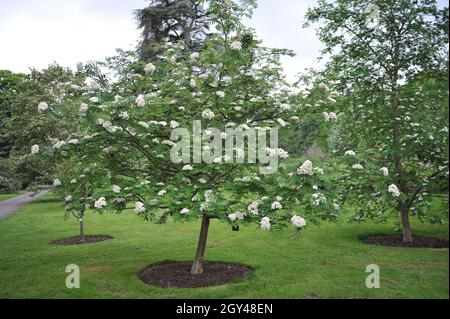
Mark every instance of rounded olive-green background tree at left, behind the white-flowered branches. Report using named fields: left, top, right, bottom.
left=3, top=64, right=83, bottom=187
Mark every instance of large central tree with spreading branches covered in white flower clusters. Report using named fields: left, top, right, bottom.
left=39, top=0, right=337, bottom=274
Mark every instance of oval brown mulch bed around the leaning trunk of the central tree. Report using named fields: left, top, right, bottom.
left=138, top=261, right=252, bottom=288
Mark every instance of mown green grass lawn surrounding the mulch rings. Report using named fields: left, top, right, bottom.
left=0, top=194, right=449, bottom=298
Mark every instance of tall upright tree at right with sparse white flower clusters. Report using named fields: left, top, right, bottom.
left=305, top=0, right=448, bottom=242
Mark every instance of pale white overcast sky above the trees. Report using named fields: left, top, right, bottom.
left=0, top=0, right=448, bottom=80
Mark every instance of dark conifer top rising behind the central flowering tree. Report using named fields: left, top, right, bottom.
left=135, top=0, right=208, bottom=61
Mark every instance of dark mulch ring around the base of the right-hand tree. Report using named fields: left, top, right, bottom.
left=361, top=235, right=448, bottom=248
